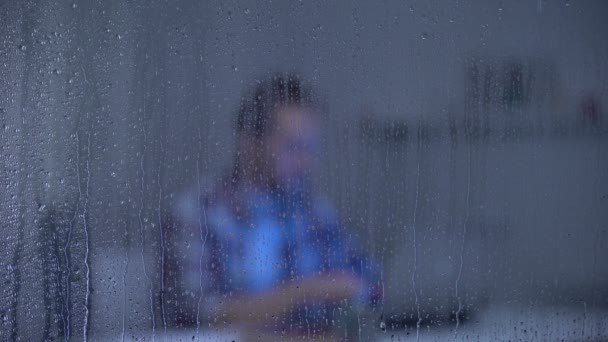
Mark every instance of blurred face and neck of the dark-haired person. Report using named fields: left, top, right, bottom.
left=269, top=107, right=320, bottom=193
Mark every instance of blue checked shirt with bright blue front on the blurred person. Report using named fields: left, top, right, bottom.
left=173, top=184, right=381, bottom=332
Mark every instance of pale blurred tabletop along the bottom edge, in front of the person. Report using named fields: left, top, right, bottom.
left=107, top=304, right=608, bottom=342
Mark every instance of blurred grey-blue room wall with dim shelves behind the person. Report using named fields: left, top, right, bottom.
left=0, top=0, right=608, bottom=338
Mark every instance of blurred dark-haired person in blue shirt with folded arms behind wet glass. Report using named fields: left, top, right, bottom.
left=169, top=74, right=381, bottom=335
